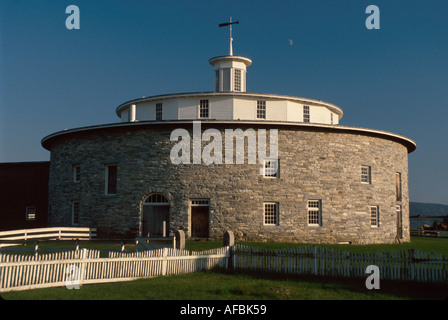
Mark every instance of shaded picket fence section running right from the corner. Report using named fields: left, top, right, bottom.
left=232, top=244, right=448, bottom=284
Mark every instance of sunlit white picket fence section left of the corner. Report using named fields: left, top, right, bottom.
left=0, top=247, right=230, bottom=292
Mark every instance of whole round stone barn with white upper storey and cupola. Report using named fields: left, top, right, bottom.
left=42, top=45, right=416, bottom=244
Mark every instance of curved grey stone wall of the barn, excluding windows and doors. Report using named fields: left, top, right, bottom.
left=49, top=123, right=410, bottom=244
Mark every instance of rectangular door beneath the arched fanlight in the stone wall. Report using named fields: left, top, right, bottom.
left=142, top=205, right=170, bottom=238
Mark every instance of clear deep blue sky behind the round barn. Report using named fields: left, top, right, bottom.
left=0, top=0, right=448, bottom=204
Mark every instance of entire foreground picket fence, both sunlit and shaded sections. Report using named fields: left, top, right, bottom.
left=0, top=244, right=448, bottom=292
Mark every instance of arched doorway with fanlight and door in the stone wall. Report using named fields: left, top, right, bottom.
left=142, top=193, right=170, bottom=238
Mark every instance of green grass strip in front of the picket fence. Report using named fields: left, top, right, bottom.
left=2, top=271, right=448, bottom=300
